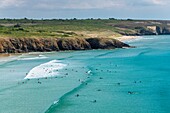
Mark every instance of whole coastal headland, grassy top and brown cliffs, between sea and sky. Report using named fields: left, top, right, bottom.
left=0, top=18, right=170, bottom=53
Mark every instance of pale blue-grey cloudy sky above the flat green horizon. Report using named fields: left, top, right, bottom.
left=0, top=0, right=170, bottom=19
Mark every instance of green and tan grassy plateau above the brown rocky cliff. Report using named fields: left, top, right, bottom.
left=0, top=18, right=170, bottom=38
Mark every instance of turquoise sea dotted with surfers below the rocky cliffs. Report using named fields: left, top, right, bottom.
left=0, top=36, right=170, bottom=113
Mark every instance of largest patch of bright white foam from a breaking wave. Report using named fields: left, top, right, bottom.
left=24, top=60, right=66, bottom=79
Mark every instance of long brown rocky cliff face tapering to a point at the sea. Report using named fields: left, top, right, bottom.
left=0, top=38, right=130, bottom=53
